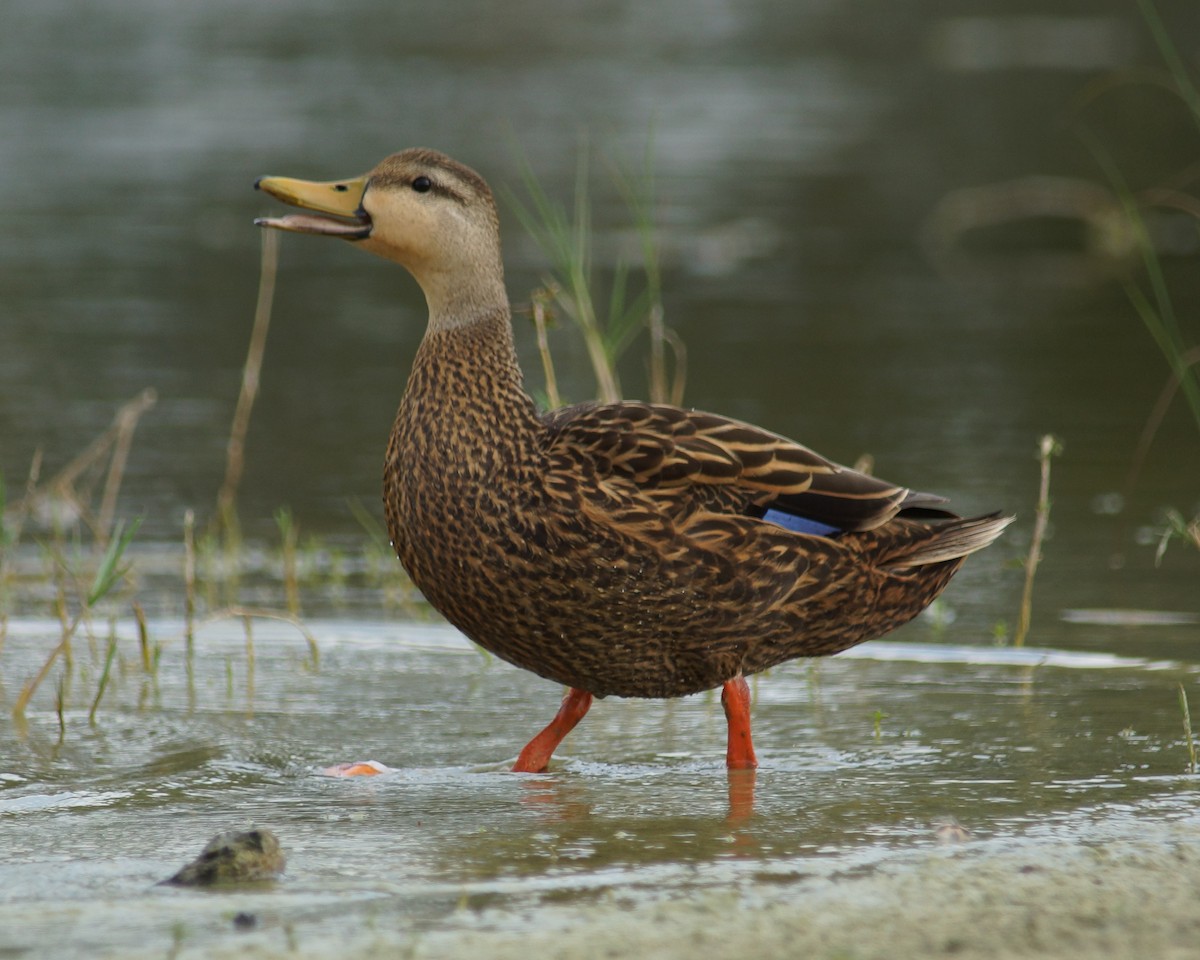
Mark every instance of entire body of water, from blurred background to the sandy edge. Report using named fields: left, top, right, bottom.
left=0, top=0, right=1200, bottom=958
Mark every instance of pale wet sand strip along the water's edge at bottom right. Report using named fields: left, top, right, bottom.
left=142, top=822, right=1200, bottom=960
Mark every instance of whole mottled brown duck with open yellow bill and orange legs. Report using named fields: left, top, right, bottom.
left=260, top=150, right=1009, bottom=769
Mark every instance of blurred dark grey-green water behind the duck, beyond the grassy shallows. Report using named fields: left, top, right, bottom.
left=0, top=0, right=1200, bottom=672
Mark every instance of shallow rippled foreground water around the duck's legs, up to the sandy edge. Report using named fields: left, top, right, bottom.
left=0, top=620, right=1200, bottom=956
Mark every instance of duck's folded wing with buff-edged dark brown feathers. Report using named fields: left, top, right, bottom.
left=544, top=402, right=942, bottom=534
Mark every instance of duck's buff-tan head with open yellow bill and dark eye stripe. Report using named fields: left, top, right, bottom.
left=254, top=148, right=508, bottom=323
